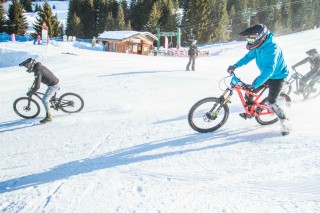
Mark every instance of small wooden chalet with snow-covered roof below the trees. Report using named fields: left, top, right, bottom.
left=97, top=31, right=158, bottom=55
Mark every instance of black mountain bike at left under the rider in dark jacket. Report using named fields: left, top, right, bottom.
left=13, top=88, right=84, bottom=119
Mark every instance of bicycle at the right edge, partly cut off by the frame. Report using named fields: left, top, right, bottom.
left=282, top=69, right=320, bottom=99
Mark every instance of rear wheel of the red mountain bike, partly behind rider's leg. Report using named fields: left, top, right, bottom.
left=255, top=93, right=291, bottom=125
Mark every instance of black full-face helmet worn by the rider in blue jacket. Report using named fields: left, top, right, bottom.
left=239, top=24, right=269, bottom=50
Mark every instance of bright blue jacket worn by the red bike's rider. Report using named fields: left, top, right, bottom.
left=234, top=32, right=289, bottom=88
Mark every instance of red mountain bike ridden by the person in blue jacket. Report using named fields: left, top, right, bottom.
left=188, top=73, right=291, bottom=133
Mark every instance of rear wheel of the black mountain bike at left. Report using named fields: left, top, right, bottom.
left=58, top=93, right=84, bottom=113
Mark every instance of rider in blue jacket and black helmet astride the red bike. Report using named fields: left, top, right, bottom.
left=227, top=24, right=291, bottom=135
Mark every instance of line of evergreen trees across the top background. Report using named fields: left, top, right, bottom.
left=0, top=0, right=320, bottom=44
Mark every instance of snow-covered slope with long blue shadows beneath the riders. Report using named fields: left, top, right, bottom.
left=0, top=29, right=320, bottom=213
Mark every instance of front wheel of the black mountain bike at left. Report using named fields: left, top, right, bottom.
left=13, top=97, right=40, bottom=119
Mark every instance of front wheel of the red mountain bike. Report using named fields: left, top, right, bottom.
left=188, top=97, right=229, bottom=133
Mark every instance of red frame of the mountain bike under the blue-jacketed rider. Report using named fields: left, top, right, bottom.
left=220, top=75, right=274, bottom=116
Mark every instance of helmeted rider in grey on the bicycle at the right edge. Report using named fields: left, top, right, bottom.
left=292, top=49, right=320, bottom=94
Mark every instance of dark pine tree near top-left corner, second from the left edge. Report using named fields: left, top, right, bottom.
left=7, top=0, right=28, bottom=35
